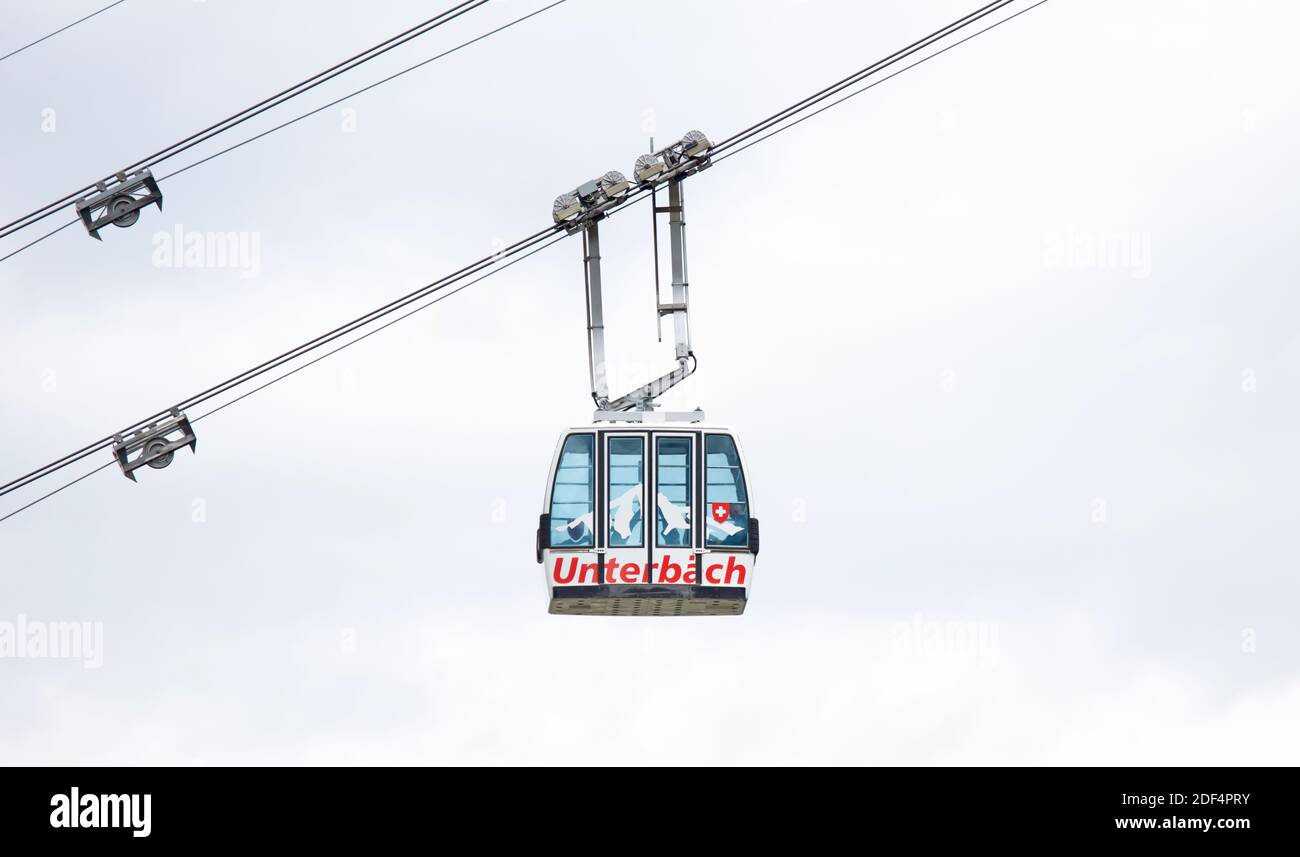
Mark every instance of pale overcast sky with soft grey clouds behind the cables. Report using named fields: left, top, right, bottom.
left=0, top=0, right=1300, bottom=765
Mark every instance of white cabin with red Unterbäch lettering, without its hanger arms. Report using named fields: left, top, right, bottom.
left=537, top=423, right=758, bottom=616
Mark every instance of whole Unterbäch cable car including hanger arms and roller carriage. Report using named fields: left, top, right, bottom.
left=537, top=131, right=759, bottom=616
